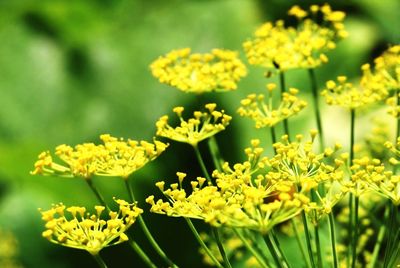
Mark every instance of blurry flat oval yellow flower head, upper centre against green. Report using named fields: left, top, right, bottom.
left=150, top=48, right=247, bottom=94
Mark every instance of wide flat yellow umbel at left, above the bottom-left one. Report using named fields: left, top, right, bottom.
left=32, top=134, right=168, bottom=179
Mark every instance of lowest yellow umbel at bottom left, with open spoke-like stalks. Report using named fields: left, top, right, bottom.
left=40, top=199, right=143, bottom=255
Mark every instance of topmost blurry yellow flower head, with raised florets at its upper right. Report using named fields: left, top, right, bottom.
left=243, top=4, right=347, bottom=71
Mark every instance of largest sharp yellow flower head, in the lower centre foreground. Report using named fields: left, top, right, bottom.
left=146, top=140, right=310, bottom=233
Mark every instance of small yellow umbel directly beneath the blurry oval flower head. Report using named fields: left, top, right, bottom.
left=156, top=103, right=232, bottom=147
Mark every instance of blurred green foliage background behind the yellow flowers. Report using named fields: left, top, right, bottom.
left=0, top=0, right=400, bottom=267
